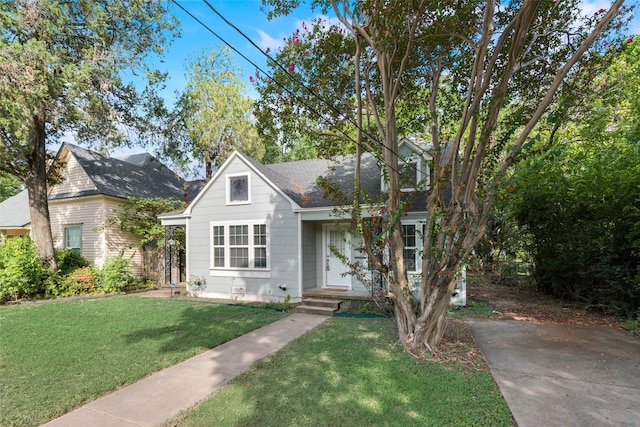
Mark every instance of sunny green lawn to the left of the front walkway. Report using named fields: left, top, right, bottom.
left=0, top=296, right=284, bottom=426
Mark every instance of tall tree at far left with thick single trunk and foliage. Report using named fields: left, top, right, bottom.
left=0, top=0, right=176, bottom=267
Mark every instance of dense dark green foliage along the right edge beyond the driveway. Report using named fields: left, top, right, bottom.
left=511, top=40, right=640, bottom=317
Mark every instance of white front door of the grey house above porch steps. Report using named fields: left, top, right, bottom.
left=323, top=224, right=351, bottom=289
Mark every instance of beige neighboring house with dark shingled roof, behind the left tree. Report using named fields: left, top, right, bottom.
left=0, top=143, right=195, bottom=278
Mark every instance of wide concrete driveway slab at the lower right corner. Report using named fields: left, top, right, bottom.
left=465, top=319, right=640, bottom=427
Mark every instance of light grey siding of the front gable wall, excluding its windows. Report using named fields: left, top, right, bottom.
left=187, top=158, right=301, bottom=302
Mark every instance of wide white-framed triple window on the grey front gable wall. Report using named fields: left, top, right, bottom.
left=211, top=222, right=269, bottom=270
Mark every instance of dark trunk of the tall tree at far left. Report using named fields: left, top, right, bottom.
left=25, top=111, right=57, bottom=270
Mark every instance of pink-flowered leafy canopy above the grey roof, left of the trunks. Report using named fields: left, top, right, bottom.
left=255, top=17, right=356, bottom=163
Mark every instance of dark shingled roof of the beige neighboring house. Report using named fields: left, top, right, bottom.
left=49, top=143, right=190, bottom=200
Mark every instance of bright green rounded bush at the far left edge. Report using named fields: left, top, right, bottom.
left=0, top=237, right=49, bottom=302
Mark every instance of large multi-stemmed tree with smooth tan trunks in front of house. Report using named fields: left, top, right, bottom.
left=265, top=0, right=624, bottom=352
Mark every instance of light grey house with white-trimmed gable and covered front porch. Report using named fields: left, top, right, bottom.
left=160, top=139, right=470, bottom=302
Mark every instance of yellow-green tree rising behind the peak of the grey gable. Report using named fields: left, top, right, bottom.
left=164, top=48, right=263, bottom=181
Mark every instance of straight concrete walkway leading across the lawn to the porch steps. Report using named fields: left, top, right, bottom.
left=44, top=313, right=327, bottom=427
